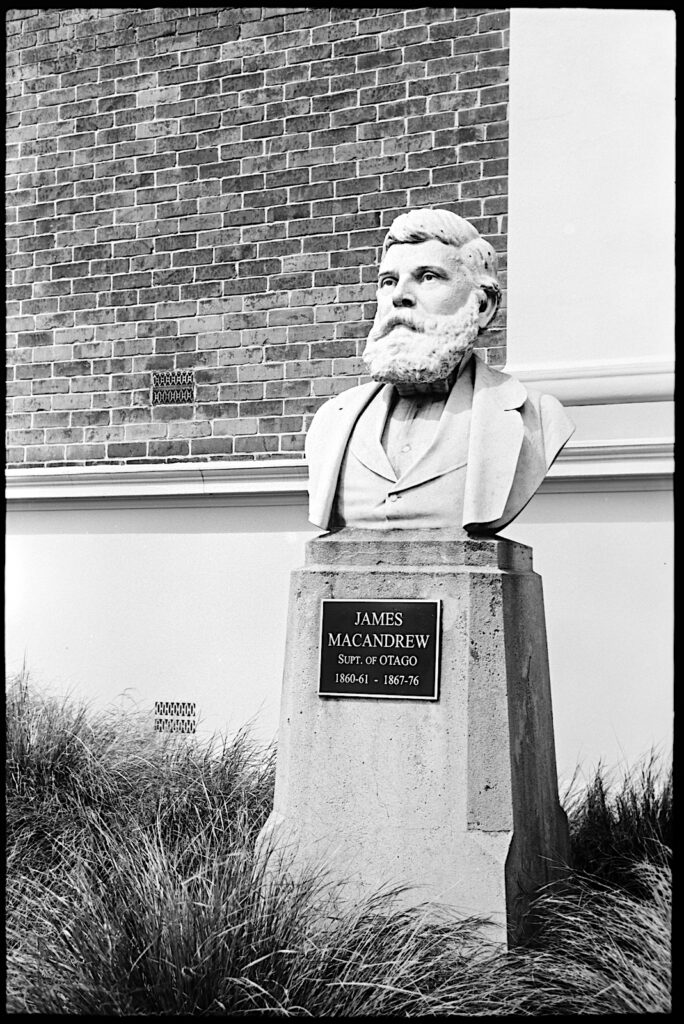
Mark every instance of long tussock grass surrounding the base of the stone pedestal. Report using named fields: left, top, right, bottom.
left=6, top=676, right=672, bottom=1017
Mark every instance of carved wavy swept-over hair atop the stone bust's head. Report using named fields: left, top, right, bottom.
left=382, top=203, right=501, bottom=305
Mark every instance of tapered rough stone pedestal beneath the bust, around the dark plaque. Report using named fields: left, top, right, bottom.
left=261, top=529, right=568, bottom=942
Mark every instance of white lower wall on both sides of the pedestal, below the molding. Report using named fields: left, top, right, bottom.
left=6, top=479, right=673, bottom=777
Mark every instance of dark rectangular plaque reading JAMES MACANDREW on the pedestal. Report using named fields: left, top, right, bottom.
left=318, top=598, right=440, bottom=700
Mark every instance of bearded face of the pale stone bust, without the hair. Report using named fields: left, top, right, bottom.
left=364, top=239, right=480, bottom=384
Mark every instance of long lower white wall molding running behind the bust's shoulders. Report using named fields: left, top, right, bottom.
left=6, top=438, right=674, bottom=510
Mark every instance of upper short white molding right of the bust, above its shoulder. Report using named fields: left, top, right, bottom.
left=505, top=359, right=675, bottom=406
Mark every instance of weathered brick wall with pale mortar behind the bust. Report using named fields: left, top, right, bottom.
left=6, top=7, right=508, bottom=467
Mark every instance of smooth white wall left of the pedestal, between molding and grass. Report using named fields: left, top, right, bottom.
left=5, top=500, right=315, bottom=742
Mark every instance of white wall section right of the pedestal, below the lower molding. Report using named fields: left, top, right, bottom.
left=503, top=490, right=674, bottom=778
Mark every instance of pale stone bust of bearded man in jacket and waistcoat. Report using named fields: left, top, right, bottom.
left=305, top=203, right=574, bottom=536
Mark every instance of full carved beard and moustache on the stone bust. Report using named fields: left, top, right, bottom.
left=362, top=293, right=479, bottom=384
